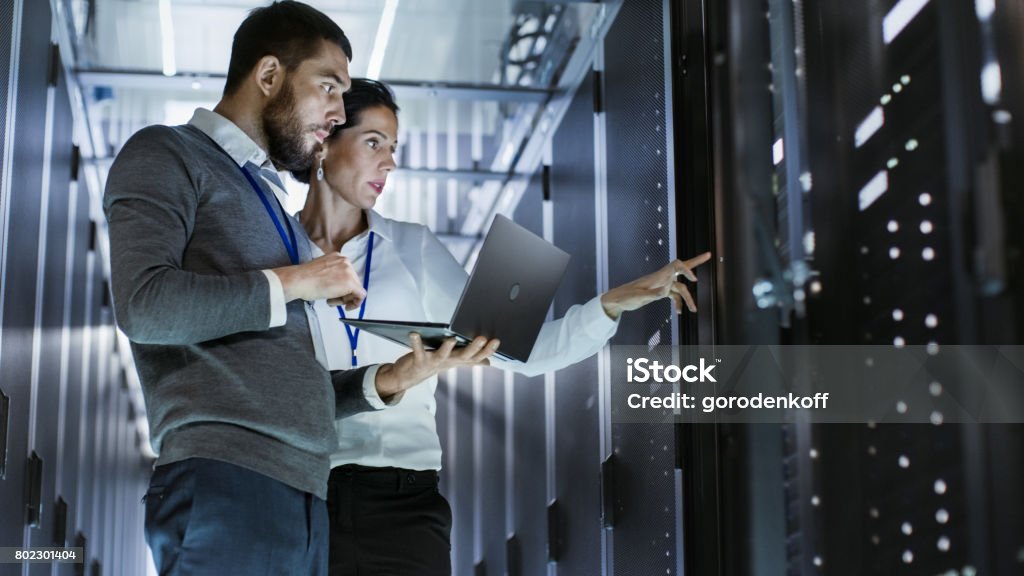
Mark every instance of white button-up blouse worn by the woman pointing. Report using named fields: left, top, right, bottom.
left=311, top=210, right=617, bottom=470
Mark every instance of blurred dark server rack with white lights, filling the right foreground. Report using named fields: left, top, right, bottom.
left=674, top=0, right=1024, bottom=574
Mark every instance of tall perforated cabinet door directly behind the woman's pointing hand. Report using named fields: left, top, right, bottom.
left=604, top=0, right=680, bottom=574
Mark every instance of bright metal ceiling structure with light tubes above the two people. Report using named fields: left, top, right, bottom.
left=62, top=0, right=611, bottom=241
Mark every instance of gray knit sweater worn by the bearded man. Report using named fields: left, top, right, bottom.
left=103, top=121, right=370, bottom=499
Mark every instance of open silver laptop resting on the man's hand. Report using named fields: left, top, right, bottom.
left=342, top=215, right=569, bottom=362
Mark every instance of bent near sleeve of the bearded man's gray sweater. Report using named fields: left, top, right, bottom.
left=103, top=126, right=270, bottom=345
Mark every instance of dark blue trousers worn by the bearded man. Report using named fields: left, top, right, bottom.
left=145, top=458, right=329, bottom=576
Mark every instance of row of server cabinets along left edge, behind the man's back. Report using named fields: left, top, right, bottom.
left=0, top=0, right=148, bottom=575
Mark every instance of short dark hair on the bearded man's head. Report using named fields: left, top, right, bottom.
left=224, top=0, right=352, bottom=95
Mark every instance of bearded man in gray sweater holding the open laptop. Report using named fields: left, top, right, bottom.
left=103, top=1, right=488, bottom=576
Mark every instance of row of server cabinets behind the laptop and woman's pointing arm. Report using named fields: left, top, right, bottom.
left=440, top=1, right=696, bottom=575
